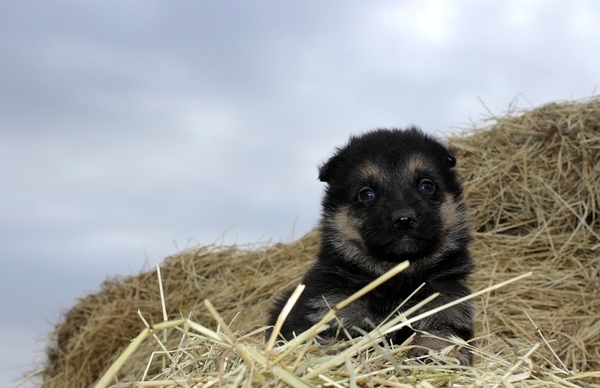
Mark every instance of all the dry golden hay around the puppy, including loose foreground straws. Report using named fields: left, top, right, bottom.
left=42, top=98, right=600, bottom=387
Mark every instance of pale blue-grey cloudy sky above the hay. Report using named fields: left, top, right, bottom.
left=0, top=0, right=600, bottom=387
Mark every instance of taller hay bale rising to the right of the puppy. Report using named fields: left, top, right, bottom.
left=449, top=98, right=600, bottom=371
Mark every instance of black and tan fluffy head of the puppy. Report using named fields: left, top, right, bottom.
left=319, top=128, right=469, bottom=268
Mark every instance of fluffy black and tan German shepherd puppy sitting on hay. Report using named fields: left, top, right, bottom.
left=270, top=127, right=474, bottom=365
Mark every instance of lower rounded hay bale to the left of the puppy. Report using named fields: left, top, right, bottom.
left=42, top=233, right=318, bottom=388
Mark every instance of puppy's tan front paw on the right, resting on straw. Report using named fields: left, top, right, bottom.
left=408, top=334, right=473, bottom=366
